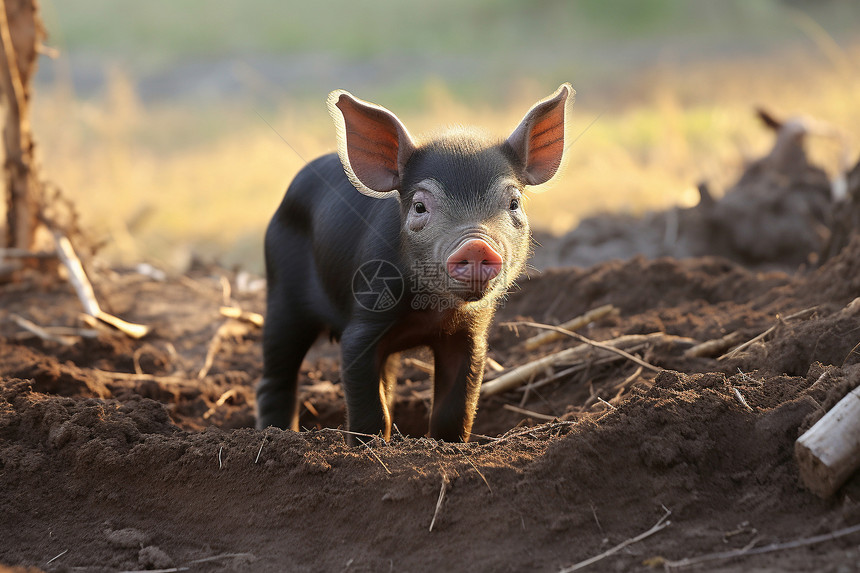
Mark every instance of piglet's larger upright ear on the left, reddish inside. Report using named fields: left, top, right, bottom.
left=328, top=90, right=415, bottom=197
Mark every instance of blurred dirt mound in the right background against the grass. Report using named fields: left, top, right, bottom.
left=533, top=112, right=848, bottom=270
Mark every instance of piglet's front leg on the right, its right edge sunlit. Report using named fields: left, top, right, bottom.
left=430, top=329, right=487, bottom=442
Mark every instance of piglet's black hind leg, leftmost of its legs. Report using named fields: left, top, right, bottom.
left=257, top=288, right=322, bottom=430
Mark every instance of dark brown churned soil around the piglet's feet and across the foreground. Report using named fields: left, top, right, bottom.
left=0, top=230, right=860, bottom=571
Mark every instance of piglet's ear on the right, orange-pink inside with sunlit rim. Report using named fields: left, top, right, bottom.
left=507, top=83, right=576, bottom=185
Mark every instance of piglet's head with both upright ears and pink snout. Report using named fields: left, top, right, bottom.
left=328, top=84, right=574, bottom=304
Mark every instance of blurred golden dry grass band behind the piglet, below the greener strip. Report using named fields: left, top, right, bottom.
left=23, top=41, right=860, bottom=271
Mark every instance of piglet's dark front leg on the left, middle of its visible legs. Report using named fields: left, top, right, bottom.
left=340, top=321, right=391, bottom=445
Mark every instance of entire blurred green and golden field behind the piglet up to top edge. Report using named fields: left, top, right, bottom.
left=26, top=0, right=860, bottom=272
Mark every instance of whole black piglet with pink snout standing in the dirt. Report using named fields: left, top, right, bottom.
left=257, top=84, right=574, bottom=444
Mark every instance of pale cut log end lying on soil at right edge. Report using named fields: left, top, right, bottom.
left=794, top=388, right=860, bottom=498
